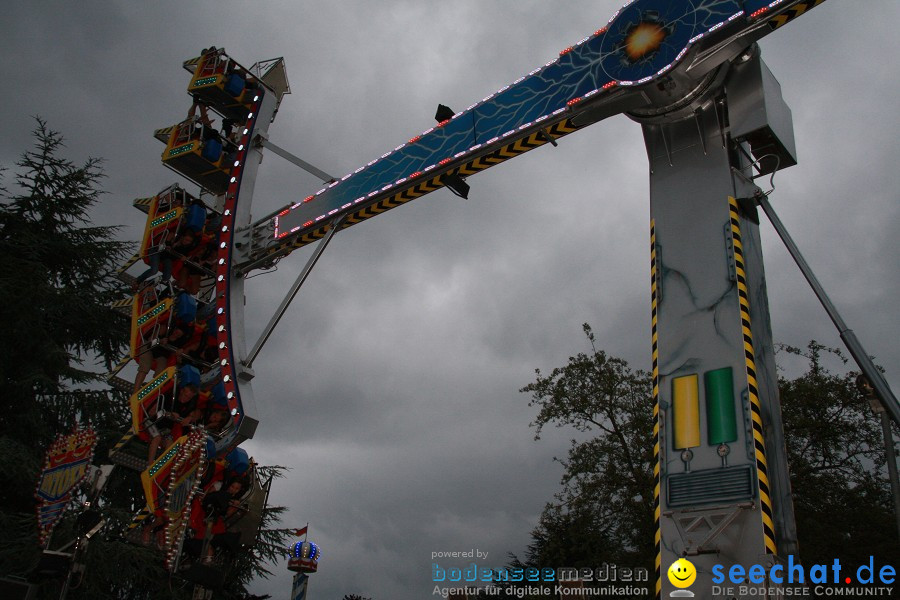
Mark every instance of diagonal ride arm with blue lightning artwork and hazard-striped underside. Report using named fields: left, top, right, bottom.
left=235, top=0, right=824, bottom=274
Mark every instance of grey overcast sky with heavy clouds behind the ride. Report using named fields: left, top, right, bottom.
left=0, top=0, right=900, bottom=600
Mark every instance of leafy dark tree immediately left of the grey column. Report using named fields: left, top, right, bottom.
left=521, top=324, right=653, bottom=568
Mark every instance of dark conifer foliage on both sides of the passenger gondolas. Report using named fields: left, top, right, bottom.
left=0, top=119, right=289, bottom=600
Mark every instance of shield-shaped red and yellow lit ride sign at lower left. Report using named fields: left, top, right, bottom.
left=34, top=427, right=97, bottom=546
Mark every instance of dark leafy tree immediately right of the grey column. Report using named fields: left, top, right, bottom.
left=779, top=341, right=900, bottom=567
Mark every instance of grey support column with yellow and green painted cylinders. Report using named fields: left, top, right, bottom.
left=640, top=54, right=797, bottom=598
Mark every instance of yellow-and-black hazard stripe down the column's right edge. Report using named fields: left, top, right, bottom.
left=728, top=197, right=778, bottom=555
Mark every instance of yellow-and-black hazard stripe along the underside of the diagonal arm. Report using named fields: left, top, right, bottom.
left=266, top=119, right=578, bottom=256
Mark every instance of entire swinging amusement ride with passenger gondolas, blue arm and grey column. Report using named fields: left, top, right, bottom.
left=61, top=0, right=900, bottom=597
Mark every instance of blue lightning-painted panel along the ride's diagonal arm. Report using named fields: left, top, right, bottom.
left=275, top=0, right=821, bottom=246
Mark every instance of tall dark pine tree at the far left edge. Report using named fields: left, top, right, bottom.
left=0, top=119, right=130, bottom=513
